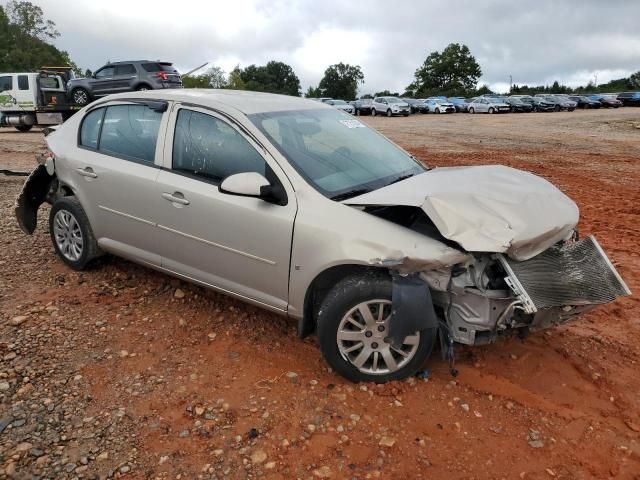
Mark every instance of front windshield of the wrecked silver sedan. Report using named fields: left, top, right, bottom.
left=249, top=109, right=425, bottom=200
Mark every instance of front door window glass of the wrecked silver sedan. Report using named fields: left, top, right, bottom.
left=172, top=109, right=267, bottom=182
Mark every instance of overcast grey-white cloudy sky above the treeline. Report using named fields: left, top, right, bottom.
left=28, top=0, right=640, bottom=93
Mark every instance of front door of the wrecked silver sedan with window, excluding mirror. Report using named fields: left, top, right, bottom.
left=155, top=107, right=297, bottom=311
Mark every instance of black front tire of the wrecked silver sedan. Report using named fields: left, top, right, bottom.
left=317, top=272, right=437, bottom=383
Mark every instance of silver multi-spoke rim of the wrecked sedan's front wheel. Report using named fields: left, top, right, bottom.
left=336, top=299, right=420, bottom=375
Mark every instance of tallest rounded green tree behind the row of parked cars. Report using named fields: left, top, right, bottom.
left=407, top=43, right=482, bottom=97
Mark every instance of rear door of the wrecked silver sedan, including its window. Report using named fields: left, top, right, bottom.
left=61, top=103, right=166, bottom=265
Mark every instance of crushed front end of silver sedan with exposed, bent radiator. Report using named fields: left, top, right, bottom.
left=421, top=237, right=631, bottom=345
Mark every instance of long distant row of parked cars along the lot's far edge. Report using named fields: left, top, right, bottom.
left=340, top=92, right=640, bottom=116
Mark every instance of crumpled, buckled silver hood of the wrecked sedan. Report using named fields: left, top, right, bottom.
left=343, top=165, right=579, bottom=260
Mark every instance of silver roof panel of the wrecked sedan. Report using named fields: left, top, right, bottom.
left=104, top=88, right=332, bottom=115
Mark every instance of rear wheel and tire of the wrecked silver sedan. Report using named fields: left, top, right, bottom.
left=49, top=197, right=102, bottom=270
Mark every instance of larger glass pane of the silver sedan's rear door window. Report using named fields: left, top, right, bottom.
left=99, top=105, right=162, bottom=163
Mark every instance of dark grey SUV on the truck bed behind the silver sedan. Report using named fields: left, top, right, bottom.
left=67, top=60, right=182, bottom=105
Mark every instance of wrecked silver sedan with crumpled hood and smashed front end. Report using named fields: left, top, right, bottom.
left=16, top=90, right=629, bottom=382
